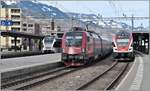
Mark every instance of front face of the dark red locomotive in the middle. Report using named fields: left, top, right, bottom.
left=61, top=32, right=87, bottom=66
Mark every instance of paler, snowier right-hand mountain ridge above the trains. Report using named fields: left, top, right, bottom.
left=67, top=12, right=130, bottom=29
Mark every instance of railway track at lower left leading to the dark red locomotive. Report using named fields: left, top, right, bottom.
left=1, top=67, right=81, bottom=90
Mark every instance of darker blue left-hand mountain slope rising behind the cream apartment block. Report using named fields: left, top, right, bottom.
left=2, top=0, right=68, bottom=18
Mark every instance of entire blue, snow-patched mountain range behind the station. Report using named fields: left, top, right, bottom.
left=1, top=0, right=130, bottom=28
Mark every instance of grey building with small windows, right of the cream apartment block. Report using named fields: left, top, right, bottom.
left=21, top=16, right=41, bottom=50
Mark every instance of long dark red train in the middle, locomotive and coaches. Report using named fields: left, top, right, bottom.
left=61, top=27, right=112, bottom=66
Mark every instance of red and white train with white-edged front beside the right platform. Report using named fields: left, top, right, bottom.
left=113, top=30, right=134, bottom=60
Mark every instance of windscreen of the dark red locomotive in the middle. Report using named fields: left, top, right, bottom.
left=66, top=32, right=82, bottom=47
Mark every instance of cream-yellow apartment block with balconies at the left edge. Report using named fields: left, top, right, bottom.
left=0, top=8, right=22, bottom=49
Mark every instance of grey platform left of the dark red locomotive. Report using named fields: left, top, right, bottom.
left=0, top=53, right=61, bottom=72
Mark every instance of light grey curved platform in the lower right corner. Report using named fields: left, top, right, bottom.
left=115, top=52, right=150, bottom=91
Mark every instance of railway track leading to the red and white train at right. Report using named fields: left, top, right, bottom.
left=76, top=61, right=129, bottom=90
